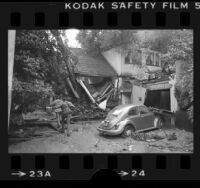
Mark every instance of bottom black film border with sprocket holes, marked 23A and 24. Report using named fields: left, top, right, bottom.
left=7, top=154, right=195, bottom=180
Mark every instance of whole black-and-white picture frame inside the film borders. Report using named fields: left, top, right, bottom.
left=8, top=28, right=194, bottom=154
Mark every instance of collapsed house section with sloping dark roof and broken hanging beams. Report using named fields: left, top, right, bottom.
left=71, top=48, right=117, bottom=110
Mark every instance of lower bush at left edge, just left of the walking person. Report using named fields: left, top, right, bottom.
left=10, top=77, right=53, bottom=124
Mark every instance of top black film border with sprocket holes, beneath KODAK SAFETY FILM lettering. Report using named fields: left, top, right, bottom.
left=0, top=2, right=200, bottom=29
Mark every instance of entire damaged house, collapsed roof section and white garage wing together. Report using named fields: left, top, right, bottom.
left=71, top=46, right=177, bottom=111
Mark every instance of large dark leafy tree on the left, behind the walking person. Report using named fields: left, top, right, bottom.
left=10, top=30, right=73, bottom=124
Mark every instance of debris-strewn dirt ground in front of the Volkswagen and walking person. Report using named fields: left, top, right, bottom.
left=8, top=121, right=193, bottom=153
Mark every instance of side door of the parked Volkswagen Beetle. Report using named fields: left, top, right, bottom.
left=139, top=106, right=154, bottom=130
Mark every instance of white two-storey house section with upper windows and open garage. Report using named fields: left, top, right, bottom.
left=102, top=47, right=177, bottom=111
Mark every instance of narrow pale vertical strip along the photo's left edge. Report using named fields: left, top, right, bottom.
left=8, top=30, right=16, bottom=130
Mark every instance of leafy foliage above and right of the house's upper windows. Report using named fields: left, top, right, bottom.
left=143, top=30, right=193, bottom=122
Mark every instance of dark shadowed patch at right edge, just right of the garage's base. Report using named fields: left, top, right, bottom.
left=175, top=110, right=193, bottom=132
